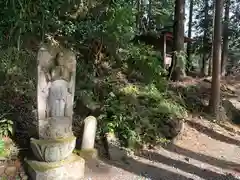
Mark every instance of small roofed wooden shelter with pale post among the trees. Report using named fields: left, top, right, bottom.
left=134, top=31, right=192, bottom=68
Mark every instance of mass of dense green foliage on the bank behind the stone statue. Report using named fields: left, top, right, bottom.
left=0, top=0, right=186, bottom=147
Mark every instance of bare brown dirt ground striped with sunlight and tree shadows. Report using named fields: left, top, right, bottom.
left=85, top=78, right=240, bottom=180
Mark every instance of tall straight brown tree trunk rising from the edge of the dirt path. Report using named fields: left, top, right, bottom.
left=209, top=0, right=223, bottom=119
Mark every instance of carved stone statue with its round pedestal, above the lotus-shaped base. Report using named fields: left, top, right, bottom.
left=38, top=47, right=76, bottom=138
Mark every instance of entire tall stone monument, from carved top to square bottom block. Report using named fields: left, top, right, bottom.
left=26, top=44, right=85, bottom=180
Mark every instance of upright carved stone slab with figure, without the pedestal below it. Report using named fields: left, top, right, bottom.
left=39, top=49, right=75, bottom=119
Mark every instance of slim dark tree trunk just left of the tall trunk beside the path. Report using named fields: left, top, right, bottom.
left=201, top=0, right=209, bottom=76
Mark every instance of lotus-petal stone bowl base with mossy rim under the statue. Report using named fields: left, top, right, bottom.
left=30, top=136, right=76, bottom=162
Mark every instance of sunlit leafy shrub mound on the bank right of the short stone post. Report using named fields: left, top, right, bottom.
left=98, top=81, right=186, bottom=147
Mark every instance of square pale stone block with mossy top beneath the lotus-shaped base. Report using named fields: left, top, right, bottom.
left=25, top=154, right=85, bottom=180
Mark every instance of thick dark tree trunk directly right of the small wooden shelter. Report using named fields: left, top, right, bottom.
left=171, top=0, right=185, bottom=81
